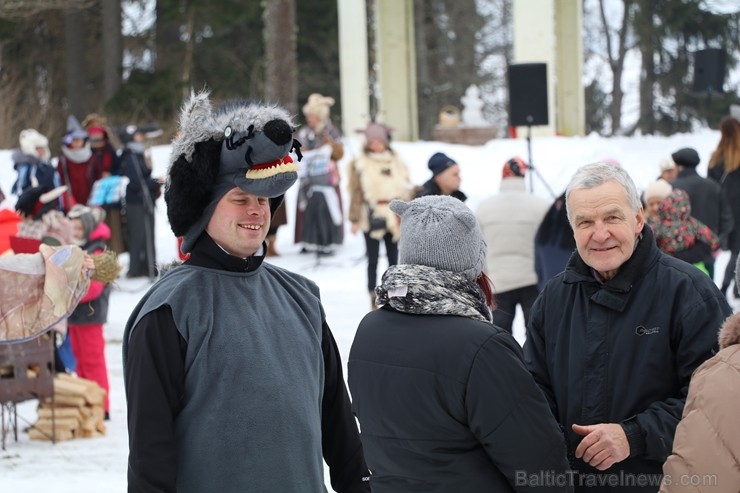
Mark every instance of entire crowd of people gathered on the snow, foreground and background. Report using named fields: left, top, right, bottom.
left=1, top=92, right=740, bottom=493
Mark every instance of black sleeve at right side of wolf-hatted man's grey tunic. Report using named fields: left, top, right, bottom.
left=321, top=322, right=370, bottom=493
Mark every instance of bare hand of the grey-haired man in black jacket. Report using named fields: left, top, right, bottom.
left=572, top=423, right=630, bottom=471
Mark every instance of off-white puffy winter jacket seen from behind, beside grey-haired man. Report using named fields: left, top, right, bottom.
left=475, top=177, right=550, bottom=293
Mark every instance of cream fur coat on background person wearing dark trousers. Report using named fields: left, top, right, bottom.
left=348, top=150, right=411, bottom=241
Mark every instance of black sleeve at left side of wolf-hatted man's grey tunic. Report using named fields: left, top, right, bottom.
left=125, top=306, right=186, bottom=493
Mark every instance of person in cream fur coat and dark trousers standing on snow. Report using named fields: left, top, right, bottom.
left=348, top=123, right=411, bottom=309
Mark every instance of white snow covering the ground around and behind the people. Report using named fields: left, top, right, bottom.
left=0, top=130, right=729, bottom=493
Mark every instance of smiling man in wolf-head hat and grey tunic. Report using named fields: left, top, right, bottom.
left=123, top=93, right=370, bottom=493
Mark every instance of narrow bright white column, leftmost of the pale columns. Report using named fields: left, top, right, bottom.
left=337, top=0, right=370, bottom=135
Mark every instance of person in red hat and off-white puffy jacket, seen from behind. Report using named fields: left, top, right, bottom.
left=476, top=157, right=550, bottom=333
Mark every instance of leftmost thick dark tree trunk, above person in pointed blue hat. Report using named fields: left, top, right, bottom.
left=64, top=9, right=87, bottom=119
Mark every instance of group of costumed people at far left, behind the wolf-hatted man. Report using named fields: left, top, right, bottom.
left=0, top=113, right=161, bottom=419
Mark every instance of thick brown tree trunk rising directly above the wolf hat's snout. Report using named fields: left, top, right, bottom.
left=264, top=0, right=298, bottom=114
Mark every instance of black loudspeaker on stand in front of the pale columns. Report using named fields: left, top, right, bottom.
left=509, top=63, right=548, bottom=127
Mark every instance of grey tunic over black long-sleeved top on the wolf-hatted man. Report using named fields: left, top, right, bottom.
left=123, top=233, right=369, bottom=493
